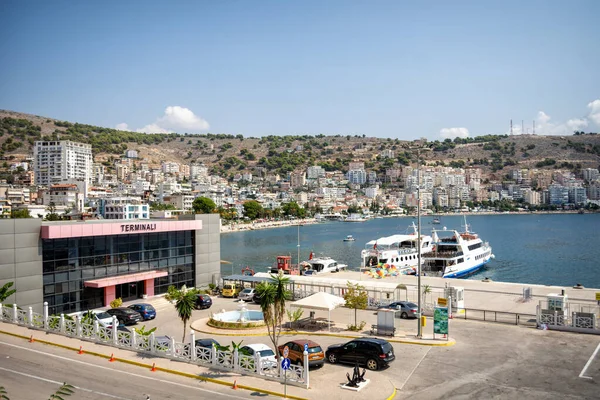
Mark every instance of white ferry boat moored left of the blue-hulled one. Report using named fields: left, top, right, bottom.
left=360, top=223, right=433, bottom=274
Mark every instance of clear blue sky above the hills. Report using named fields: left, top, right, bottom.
left=0, top=0, right=600, bottom=140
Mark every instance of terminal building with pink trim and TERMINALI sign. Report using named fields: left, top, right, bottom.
left=0, top=214, right=221, bottom=314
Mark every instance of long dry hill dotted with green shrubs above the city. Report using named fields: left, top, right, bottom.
left=0, top=110, right=600, bottom=177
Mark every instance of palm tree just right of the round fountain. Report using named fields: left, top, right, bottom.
left=256, top=271, right=292, bottom=358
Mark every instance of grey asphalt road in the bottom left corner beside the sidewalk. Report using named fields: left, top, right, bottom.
left=0, top=335, right=256, bottom=400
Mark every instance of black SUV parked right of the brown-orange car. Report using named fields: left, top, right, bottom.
left=325, top=338, right=396, bottom=371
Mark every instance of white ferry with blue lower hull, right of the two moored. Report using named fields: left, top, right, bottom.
left=423, top=218, right=494, bottom=278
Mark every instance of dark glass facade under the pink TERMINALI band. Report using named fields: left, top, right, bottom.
left=42, top=231, right=195, bottom=314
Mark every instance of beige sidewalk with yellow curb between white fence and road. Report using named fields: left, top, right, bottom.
left=0, top=322, right=396, bottom=400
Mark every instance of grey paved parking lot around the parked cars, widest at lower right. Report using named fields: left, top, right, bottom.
left=115, top=297, right=600, bottom=399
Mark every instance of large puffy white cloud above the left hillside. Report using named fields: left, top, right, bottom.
left=116, top=106, right=210, bottom=133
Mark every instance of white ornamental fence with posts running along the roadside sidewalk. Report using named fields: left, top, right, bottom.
left=0, top=303, right=309, bottom=388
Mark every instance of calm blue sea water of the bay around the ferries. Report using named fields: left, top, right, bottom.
left=221, top=214, right=600, bottom=288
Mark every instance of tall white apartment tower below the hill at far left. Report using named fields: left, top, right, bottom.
left=33, top=140, right=93, bottom=186
